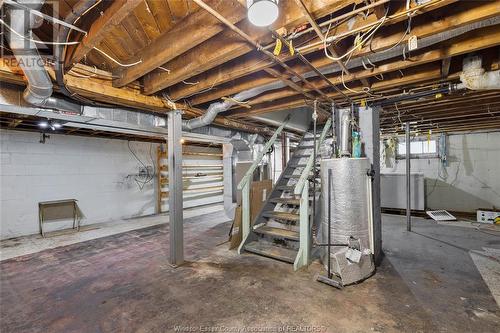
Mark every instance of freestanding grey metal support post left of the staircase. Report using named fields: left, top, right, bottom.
left=168, top=110, right=184, bottom=266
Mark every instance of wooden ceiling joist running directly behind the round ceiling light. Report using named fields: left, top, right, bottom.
left=144, top=0, right=355, bottom=95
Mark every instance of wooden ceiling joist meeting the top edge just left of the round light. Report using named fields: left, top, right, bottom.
left=113, top=0, right=246, bottom=87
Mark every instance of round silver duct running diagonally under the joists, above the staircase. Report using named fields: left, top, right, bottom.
left=182, top=81, right=285, bottom=131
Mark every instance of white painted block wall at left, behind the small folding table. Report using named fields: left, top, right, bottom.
left=0, top=130, right=222, bottom=239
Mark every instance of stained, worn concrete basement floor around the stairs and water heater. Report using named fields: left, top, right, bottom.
left=0, top=212, right=500, bottom=332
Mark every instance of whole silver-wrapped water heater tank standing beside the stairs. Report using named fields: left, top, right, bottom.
left=318, top=158, right=374, bottom=284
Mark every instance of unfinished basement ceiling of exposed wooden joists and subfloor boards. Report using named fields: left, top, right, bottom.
left=0, top=0, right=500, bottom=133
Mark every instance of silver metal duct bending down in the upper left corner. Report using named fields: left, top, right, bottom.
left=7, top=0, right=82, bottom=113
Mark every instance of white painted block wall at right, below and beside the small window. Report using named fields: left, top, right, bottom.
left=381, top=131, right=500, bottom=212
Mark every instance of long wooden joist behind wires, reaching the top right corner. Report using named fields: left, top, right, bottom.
left=169, top=1, right=499, bottom=105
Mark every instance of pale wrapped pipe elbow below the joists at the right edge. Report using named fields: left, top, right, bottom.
left=460, top=56, right=500, bottom=90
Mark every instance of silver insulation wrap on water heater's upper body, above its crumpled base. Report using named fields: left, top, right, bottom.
left=319, top=158, right=371, bottom=252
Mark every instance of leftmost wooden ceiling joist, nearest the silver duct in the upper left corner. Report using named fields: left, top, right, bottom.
left=68, top=0, right=143, bottom=68
